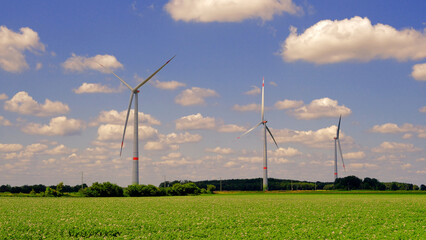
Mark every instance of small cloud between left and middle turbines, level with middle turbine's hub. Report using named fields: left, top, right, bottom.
left=175, top=113, right=216, bottom=130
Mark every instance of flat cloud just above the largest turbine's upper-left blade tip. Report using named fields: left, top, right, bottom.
left=62, top=53, right=123, bottom=73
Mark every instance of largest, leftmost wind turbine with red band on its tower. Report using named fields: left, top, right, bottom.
left=98, top=56, right=175, bottom=184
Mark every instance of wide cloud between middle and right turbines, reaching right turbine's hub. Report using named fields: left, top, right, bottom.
left=271, top=125, right=352, bottom=148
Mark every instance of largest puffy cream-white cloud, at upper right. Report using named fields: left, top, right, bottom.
left=281, top=16, right=426, bottom=64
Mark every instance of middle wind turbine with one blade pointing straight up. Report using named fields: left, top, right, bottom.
left=238, top=78, right=278, bottom=191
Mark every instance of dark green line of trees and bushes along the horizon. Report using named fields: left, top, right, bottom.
left=0, top=176, right=426, bottom=197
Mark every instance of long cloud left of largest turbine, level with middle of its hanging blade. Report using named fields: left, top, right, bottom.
left=22, top=116, right=85, bottom=136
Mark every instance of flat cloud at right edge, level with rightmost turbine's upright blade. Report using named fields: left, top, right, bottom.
left=370, top=123, right=426, bottom=139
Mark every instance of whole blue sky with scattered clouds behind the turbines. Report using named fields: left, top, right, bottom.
left=0, top=0, right=426, bottom=186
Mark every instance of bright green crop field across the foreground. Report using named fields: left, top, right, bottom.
left=0, top=193, right=426, bottom=239
